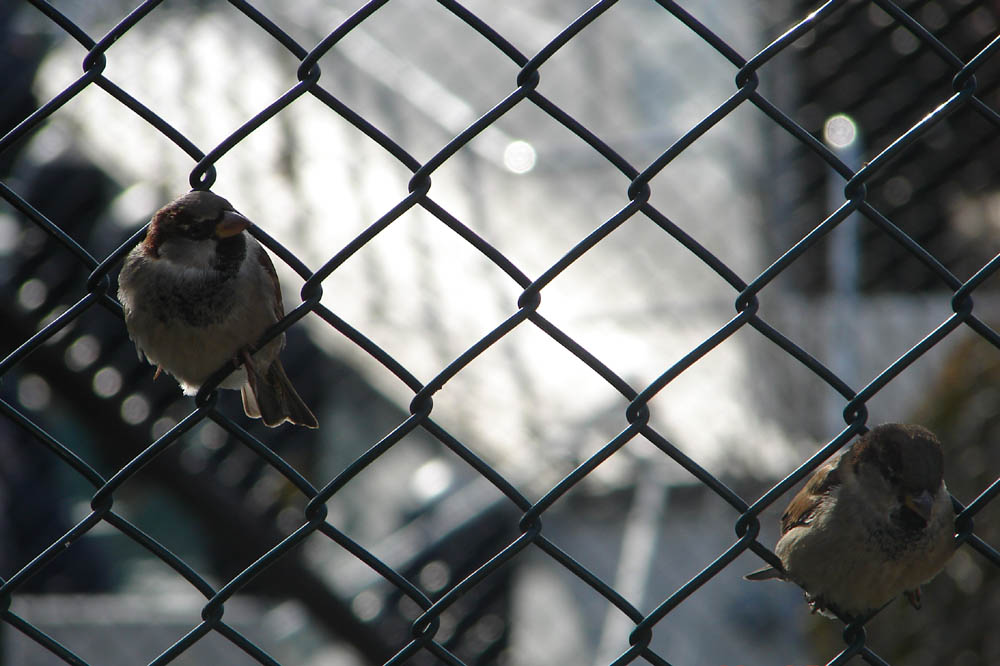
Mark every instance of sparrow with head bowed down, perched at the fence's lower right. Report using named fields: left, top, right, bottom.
left=744, top=423, right=955, bottom=621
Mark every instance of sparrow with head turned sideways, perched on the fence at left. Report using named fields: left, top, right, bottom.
left=118, top=191, right=318, bottom=428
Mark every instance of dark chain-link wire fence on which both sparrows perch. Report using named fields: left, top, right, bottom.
left=0, top=0, right=1000, bottom=666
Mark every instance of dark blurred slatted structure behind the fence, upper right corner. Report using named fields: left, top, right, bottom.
left=774, top=0, right=1000, bottom=293
